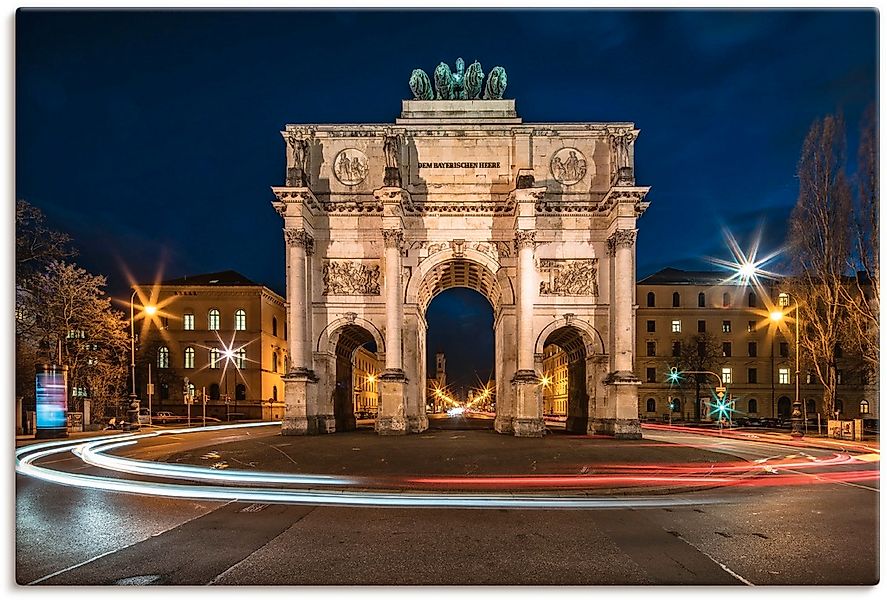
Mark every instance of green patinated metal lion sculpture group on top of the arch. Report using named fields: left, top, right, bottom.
left=410, top=57, right=508, bottom=100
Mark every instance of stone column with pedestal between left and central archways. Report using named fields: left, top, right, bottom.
left=376, top=229, right=408, bottom=435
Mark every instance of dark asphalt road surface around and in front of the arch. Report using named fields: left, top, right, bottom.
left=16, top=420, right=879, bottom=586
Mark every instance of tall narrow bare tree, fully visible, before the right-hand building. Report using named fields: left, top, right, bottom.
left=789, top=115, right=852, bottom=418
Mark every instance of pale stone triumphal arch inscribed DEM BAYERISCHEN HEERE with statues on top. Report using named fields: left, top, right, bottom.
left=272, top=59, right=649, bottom=438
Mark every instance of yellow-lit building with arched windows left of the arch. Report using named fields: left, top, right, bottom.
left=135, top=271, right=288, bottom=420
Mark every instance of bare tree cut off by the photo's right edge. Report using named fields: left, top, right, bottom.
left=842, top=105, right=881, bottom=374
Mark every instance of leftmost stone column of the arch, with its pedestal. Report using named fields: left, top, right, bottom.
left=281, top=229, right=316, bottom=435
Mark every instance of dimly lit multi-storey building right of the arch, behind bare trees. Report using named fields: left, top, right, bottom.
left=635, top=268, right=878, bottom=428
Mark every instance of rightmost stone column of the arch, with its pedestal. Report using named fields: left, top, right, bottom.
left=592, top=229, right=641, bottom=439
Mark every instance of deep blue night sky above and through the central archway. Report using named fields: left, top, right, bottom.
left=15, top=10, right=878, bottom=394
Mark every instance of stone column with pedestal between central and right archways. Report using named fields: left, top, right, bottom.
left=511, top=230, right=545, bottom=437
